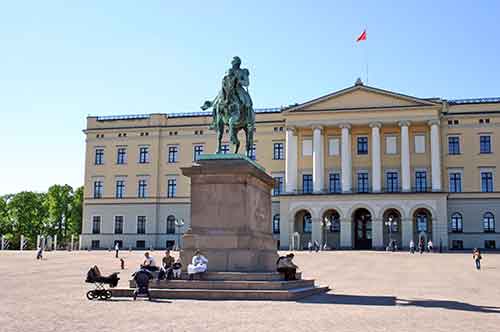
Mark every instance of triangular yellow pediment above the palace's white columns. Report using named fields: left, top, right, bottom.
left=287, top=84, right=436, bottom=112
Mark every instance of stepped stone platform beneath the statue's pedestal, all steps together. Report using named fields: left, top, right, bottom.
left=112, top=272, right=329, bottom=301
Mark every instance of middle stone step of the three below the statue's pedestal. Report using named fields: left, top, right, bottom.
left=130, top=280, right=314, bottom=290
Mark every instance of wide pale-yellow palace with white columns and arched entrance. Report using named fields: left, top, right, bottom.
left=81, top=80, right=500, bottom=249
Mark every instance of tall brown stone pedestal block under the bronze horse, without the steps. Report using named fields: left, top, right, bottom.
left=180, top=154, right=278, bottom=272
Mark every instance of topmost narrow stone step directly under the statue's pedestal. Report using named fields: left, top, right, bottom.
left=145, top=272, right=302, bottom=281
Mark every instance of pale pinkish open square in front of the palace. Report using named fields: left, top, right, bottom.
left=0, top=251, right=500, bottom=332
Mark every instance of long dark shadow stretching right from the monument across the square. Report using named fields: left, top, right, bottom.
left=297, top=293, right=500, bottom=314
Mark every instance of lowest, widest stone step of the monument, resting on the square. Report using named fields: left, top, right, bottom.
left=111, top=286, right=329, bottom=301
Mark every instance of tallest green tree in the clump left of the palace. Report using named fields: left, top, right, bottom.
left=45, top=184, right=73, bottom=241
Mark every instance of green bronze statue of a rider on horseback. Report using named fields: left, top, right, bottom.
left=201, top=56, right=255, bottom=156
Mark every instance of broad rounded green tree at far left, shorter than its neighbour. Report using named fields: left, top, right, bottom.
left=7, top=191, right=48, bottom=247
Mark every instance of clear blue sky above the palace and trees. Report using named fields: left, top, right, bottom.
left=0, top=0, right=500, bottom=194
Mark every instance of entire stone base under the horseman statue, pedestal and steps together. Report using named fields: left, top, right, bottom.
left=112, top=154, right=329, bottom=301
